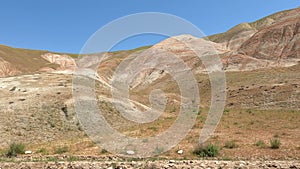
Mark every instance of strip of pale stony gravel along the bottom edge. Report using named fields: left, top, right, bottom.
left=0, top=160, right=300, bottom=169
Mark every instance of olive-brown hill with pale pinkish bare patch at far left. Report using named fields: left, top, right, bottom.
left=0, top=45, right=75, bottom=77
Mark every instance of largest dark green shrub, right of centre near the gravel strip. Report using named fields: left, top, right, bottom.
left=193, top=144, right=219, bottom=157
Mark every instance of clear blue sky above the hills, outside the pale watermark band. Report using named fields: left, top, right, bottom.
left=0, top=0, right=300, bottom=53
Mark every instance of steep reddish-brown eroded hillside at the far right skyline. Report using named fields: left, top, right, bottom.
left=238, top=8, right=300, bottom=63
